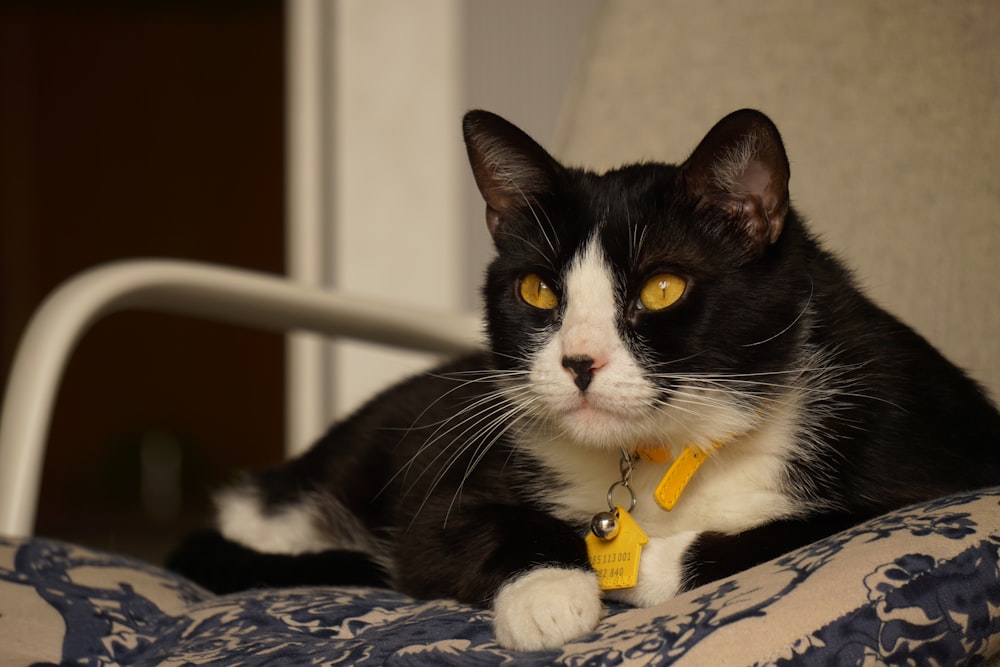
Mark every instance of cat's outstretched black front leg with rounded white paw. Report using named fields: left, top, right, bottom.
left=396, top=505, right=603, bottom=651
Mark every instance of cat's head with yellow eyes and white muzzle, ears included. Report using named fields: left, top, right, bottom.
left=464, top=110, right=810, bottom=449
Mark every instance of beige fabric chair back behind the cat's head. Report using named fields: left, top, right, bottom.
left=556, top=0, right=1000, bottom=397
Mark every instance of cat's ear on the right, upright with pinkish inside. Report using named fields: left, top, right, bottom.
left=681, top=109, right=789, bottom=256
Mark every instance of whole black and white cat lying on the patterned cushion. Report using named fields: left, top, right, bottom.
left=172, top=110, right=1000, bottom=650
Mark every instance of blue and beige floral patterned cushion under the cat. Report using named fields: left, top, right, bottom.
left=0, top=489, right=1000, bottom=667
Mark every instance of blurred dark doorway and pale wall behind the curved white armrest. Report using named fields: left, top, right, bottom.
left=0, top=0, right=597, bottom=560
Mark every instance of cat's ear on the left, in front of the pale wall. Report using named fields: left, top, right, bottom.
left=462, top=110, right=561, bottom=238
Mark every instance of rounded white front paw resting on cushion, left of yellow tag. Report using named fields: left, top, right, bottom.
left=493, top=567, right=604, bottom=651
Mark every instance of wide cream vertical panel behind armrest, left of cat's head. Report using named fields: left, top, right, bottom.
left=328, top=0, right=465, bottom=413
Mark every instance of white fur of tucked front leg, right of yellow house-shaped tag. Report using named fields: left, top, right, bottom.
left=607, top=531, right=698, bottom=607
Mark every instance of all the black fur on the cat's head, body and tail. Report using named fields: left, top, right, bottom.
left=171, top=111, right=1000, bottom=636
